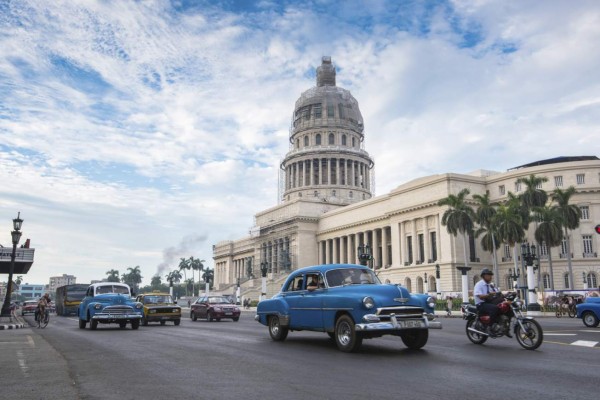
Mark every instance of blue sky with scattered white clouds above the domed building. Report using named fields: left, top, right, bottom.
left=0, top=0, right=600, bottom=284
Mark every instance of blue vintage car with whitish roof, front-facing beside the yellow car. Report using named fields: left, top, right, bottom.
left=78, top=282, right=144, bottom=330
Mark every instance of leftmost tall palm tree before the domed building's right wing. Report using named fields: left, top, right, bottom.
left=438, top=189, right=475, bottom=267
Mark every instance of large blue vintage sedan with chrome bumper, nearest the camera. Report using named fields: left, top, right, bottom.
left=255, top=264, right=442, bottom=352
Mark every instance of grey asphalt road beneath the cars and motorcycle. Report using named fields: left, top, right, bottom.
left=0, top=313, right=600, bottom=400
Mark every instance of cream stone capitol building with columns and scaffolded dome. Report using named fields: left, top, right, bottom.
left=213, top=57, right=600, bottom=299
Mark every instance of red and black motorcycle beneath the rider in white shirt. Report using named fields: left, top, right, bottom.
left=461, top=292, right=544, bottom=350
